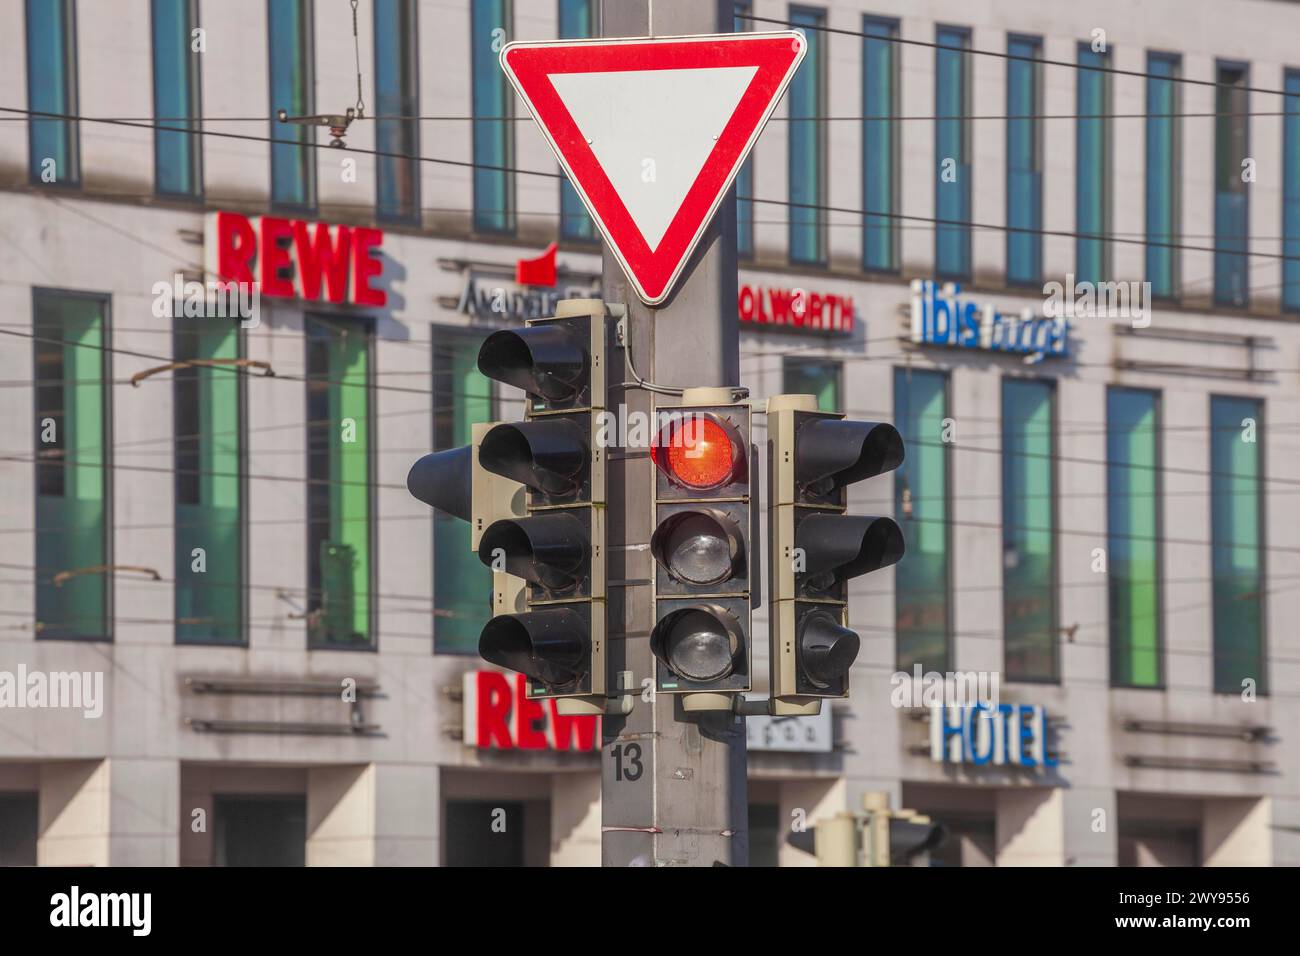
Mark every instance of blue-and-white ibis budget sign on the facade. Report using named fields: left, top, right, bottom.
left=911, top=278, right=1070, bottom=360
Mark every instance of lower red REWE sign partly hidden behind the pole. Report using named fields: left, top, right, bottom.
left=463, top=671, right=601, bottom=750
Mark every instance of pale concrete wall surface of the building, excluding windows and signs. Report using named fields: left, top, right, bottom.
left=0, top=0, right=1300, bottom=865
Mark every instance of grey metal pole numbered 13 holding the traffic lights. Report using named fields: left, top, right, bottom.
left=601, top=0, right=758, bottom=866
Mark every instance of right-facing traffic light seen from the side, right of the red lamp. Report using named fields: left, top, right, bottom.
left=767, top=395, right=904, bottom=715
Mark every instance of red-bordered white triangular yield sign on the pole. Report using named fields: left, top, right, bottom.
left=501, top=31, right=807, bottom=306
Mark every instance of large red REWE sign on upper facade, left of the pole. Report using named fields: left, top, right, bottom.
left=204, top=212, right=389, bottom=307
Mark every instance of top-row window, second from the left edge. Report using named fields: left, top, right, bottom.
left=153, top=0, right=203, bottom=198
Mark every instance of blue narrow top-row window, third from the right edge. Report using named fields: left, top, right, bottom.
left=1147, top=53, right=1182, bottom=299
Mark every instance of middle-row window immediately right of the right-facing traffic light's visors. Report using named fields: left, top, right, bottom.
left=894, top=368, right=952, bottom=672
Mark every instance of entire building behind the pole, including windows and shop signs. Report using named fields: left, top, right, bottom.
left=0, top=0, right=1300, bottom=865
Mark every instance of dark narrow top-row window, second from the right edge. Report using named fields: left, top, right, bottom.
left=1214, top=62, right=1251, bottom=308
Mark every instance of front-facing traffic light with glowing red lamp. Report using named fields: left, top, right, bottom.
left=650, top=389, right=758, bottom=710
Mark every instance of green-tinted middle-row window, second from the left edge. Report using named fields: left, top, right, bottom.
left=172, top=319, right=244, bottom=644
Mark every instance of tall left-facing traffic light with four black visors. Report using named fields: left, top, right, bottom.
left=477, top=299, right=612, bottom=713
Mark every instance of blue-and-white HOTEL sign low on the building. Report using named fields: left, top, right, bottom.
left=930, top=702, right=1057, bottom=767
